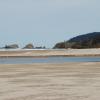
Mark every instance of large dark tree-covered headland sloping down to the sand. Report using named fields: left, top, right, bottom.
left=54, top=32, right=100, bottom=49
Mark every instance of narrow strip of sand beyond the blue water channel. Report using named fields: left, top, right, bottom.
left=0, top=48, right=100, bottom=57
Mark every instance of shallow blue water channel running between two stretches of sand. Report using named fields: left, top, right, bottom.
left=0, top=57, right=100, bottom=64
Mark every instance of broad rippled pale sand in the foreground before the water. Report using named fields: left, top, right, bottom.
left=0, top=62, right=100, bottom=100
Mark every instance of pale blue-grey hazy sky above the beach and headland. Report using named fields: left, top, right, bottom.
left=0, top=0, right=100, bottom=48
